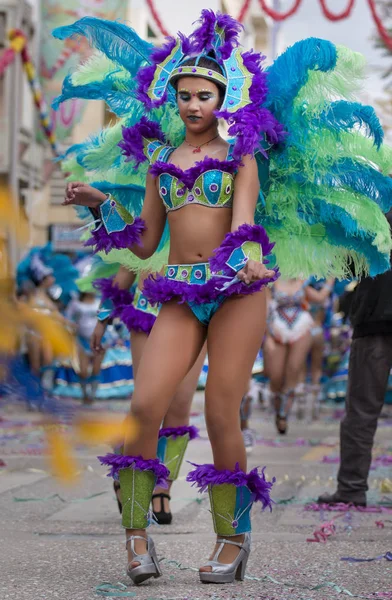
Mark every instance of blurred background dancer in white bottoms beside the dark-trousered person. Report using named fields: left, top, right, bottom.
left=264, top=279, right=332, bottom=434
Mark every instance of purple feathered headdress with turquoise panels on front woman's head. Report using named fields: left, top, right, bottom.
left=137, top=9, right=284, bottom=158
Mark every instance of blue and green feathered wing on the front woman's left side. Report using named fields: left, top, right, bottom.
left=53, top=17, right=191, bottom=270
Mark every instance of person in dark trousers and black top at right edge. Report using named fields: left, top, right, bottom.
left=318, top=211, right=392, bottom=506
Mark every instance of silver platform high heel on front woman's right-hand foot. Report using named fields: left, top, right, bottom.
left=199, top=533, right=250, bottom=583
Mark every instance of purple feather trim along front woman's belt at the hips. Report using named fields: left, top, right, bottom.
left=143, top=267, right=279, bottom=304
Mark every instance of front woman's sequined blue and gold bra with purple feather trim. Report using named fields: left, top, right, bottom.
left=145, top=140, right=239, bottom=212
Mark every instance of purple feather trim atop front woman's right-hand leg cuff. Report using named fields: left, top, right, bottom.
left=186, top=463, right=276, bottom=510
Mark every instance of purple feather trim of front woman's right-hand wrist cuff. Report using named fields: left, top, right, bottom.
left=208, top=223, right=275, bottom=275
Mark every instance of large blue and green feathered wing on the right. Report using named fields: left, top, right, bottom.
left=256, top=38, right=392, bottom=278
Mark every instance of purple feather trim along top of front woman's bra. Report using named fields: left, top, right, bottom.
left=150, top=156, right=241, bottom=190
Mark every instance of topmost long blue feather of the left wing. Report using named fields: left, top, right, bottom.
left=53, top=17, right=154, bottom=76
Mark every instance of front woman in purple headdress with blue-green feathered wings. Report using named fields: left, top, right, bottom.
left=56, top=10, right=392, bottom=583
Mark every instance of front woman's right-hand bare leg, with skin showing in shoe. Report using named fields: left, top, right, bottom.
left=200, top=292, right=266, bottom=571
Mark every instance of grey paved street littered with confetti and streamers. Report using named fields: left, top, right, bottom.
left=0, top=393, right=392, bottom=600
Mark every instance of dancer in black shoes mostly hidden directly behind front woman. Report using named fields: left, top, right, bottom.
left=91, top=267, right=206, bottom=525
